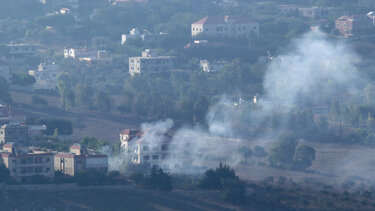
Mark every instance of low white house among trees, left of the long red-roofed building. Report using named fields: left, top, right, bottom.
left=121, top=28, right=167, bottom=45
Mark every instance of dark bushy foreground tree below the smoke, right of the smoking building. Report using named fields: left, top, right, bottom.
left=199, top=163, right=238, bottom=190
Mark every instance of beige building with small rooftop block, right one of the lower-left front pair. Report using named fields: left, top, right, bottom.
left=54, top=144, right=108, bottom=176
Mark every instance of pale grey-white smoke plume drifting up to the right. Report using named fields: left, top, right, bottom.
left=110, top=32, right=366, bottom=180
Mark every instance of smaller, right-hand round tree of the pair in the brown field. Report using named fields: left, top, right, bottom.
left=291, top=145, right=315, bottom=171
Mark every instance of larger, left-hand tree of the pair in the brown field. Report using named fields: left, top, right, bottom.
left=269, top=132, right=297, bottom=167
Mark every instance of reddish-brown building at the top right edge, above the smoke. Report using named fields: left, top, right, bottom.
left=335, top=15, right=373, bottom=37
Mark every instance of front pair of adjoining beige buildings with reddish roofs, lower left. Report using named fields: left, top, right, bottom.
left=0, top=142, right=108, bottom=182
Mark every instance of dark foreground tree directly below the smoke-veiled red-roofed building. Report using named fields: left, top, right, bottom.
left=144, top=166, right=172, bottom=191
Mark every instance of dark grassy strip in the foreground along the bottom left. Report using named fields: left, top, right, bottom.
left=0, top=185, right=241, bottom=211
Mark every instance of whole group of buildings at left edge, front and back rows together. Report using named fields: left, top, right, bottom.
left=0, top=105, right=108, bottom=182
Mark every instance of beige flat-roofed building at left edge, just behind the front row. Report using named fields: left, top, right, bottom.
left=0, top=124, right=29, bottom=143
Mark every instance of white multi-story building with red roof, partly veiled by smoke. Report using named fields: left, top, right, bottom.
left=120, top=129, right=182, bottom=169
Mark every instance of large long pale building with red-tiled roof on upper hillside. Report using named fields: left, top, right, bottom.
left=191, top=15, right=259, bottom=38
